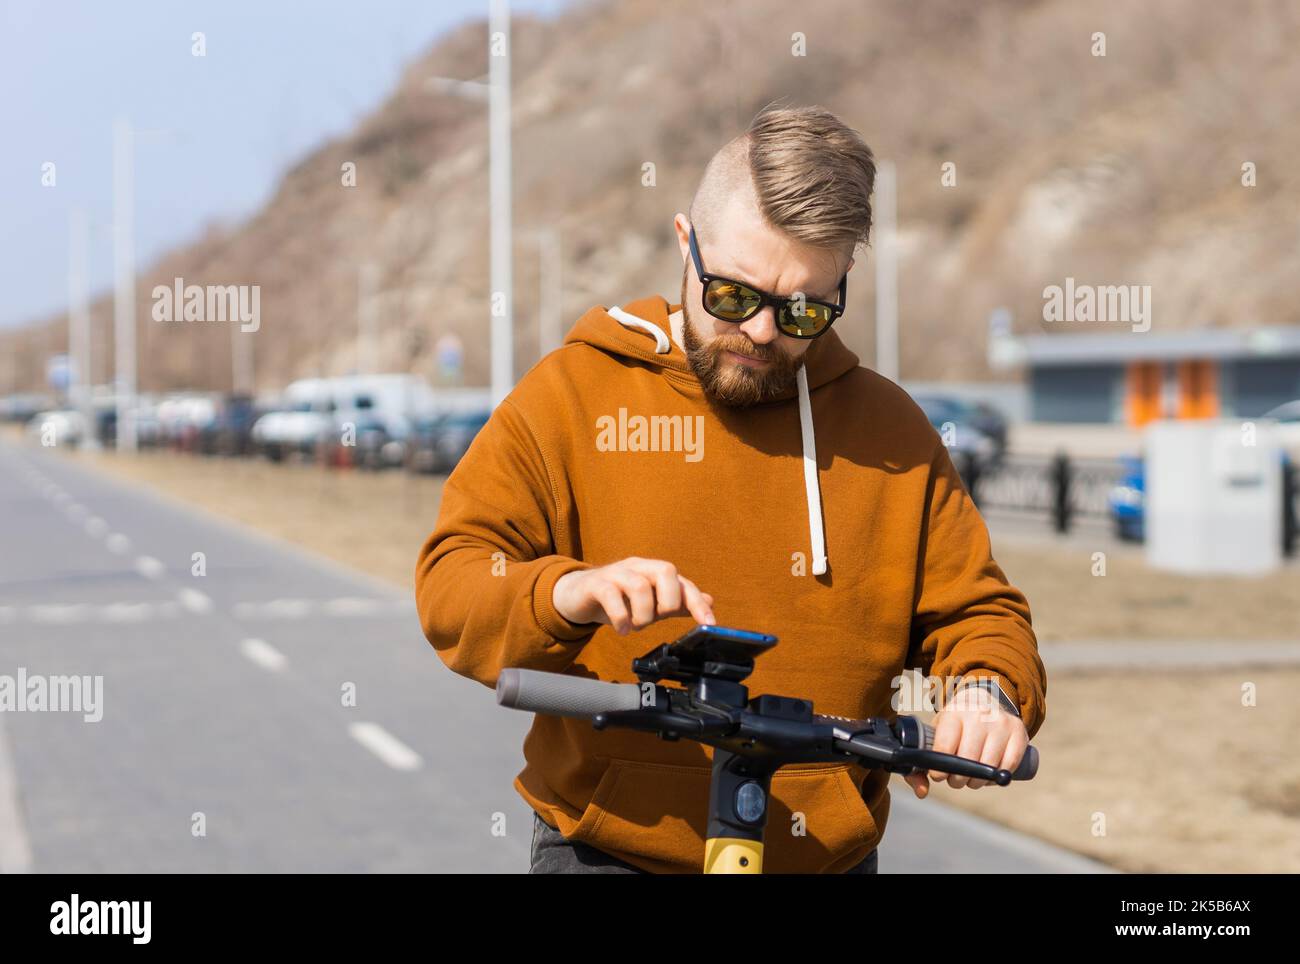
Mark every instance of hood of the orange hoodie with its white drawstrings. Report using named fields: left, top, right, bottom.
left=564, top=295, right=858, bottom=576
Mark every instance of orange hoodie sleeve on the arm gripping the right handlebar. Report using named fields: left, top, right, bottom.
left=909, top=437, right=1047, bottom=738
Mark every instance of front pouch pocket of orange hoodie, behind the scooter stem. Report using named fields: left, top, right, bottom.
left=569, top=760, right=880, bottom=873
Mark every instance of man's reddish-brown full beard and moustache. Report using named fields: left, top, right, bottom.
left=681, top=273, right=803, bottom=408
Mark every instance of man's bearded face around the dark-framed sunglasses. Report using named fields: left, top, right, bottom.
left=675, top=200, right=853, bottom=407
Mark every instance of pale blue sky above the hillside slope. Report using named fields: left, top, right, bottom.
left=0, top=0, right=564, bottom=327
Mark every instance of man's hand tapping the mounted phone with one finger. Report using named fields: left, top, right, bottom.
left=551, top=556, right=714, bottom=635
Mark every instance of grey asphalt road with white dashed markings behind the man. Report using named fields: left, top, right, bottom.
left=0, top=443, right=1100, bottom=873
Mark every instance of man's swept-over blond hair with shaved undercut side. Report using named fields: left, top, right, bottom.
left=690, top=107, right=876, bottom=256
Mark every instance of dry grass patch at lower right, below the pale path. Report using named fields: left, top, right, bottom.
left=925, top=669, right=1300, bottom=873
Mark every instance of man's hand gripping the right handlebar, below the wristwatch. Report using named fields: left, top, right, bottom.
left=904, top=687, right=1030, bottom=798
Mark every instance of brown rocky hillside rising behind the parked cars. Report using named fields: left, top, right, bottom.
left=0, top=0, right=1300, bottom=390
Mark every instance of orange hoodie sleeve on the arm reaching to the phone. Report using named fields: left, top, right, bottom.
left=415, top=399, right=597, bottom=686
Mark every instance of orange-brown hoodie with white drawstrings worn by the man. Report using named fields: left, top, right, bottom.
left=416, top=296, right=1047, bottom=873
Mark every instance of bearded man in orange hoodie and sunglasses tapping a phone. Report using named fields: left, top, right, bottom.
left=416, top=108, right=1047, bottom=873
